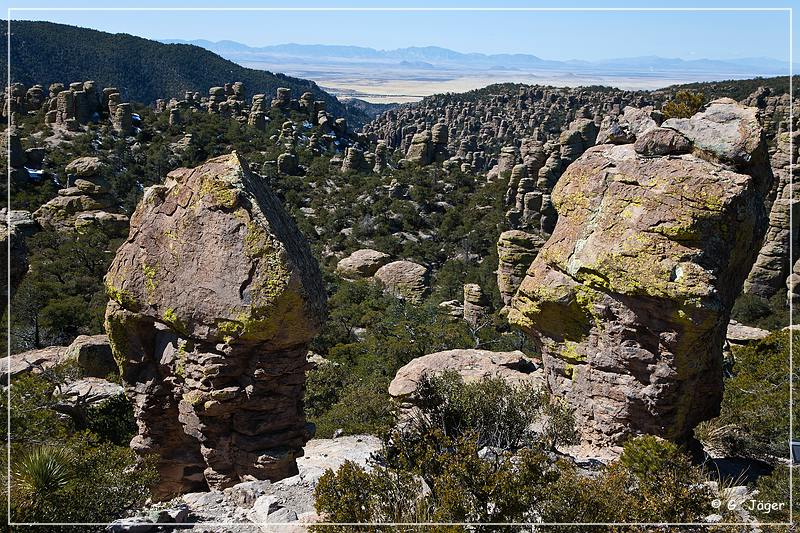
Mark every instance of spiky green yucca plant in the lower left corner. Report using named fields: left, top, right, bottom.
left=12, top=446, right=72, bottom=505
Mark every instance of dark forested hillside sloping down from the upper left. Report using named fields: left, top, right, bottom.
left=0, top=20, right=367, bottom=122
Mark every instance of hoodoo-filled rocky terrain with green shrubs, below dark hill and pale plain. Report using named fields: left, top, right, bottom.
left=0, top=28, right=800, bottom=532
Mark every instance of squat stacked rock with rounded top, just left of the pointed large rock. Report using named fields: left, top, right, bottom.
left=33, top=157, right=128, bottom=235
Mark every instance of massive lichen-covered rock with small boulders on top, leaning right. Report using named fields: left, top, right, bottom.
left=508, top=101, right=771, bottom=447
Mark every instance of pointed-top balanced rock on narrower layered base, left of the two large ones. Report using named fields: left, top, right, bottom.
left=106, top=152, right=325, bottom=498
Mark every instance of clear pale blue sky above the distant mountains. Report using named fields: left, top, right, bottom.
left=9, top=0, right=800, bottom=62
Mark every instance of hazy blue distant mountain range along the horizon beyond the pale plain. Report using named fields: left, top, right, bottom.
left=162, top=39, right=788, bottom=78
